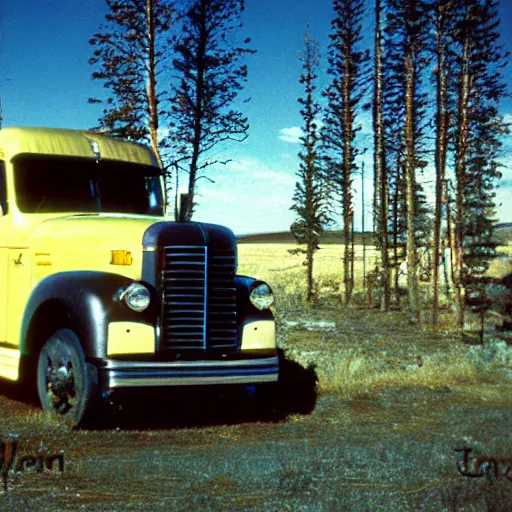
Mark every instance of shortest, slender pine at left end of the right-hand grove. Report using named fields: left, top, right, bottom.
left=290, top=32, right=327, bottom=302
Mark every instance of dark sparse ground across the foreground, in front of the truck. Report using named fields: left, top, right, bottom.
left=0, top=308, right=512, bottom=511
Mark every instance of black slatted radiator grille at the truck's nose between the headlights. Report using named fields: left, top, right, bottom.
left=161, top=246, right=238, bottom=351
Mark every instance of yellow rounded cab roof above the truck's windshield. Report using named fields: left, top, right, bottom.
left=0, top=127, right=158, bottom=167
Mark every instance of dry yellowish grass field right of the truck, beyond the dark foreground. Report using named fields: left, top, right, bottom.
left=239, top=244, right=512, bottom=397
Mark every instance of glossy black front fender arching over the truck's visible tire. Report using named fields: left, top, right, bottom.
left=21, top=271, right=158, bottom=358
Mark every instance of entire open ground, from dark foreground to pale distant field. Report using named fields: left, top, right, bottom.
left=0, top=244, right=512, bottom=512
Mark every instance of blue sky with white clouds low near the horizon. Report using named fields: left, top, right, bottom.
left=0, top=0, right=512, bottom=233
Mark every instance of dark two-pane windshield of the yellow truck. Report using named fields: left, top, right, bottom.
left=13, top=154, right=164, bottom=216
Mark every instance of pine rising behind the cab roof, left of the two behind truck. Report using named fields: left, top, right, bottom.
left=89, top=0, right=174, bottom=164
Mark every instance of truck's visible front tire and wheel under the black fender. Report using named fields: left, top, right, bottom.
left=37, top=329, right=99, bottom=427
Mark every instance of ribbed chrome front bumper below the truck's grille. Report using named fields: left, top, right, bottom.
left=97, top=356, right=279, bottom=390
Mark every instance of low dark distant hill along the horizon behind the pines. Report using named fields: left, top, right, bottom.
left=237, top=222, right=512, bottom=245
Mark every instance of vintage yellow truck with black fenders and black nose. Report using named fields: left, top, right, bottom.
left=0, top=128, right=279, bottom=426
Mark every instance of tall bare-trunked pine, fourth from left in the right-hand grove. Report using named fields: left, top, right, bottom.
left=380, top=0, right=429, bottom=319
